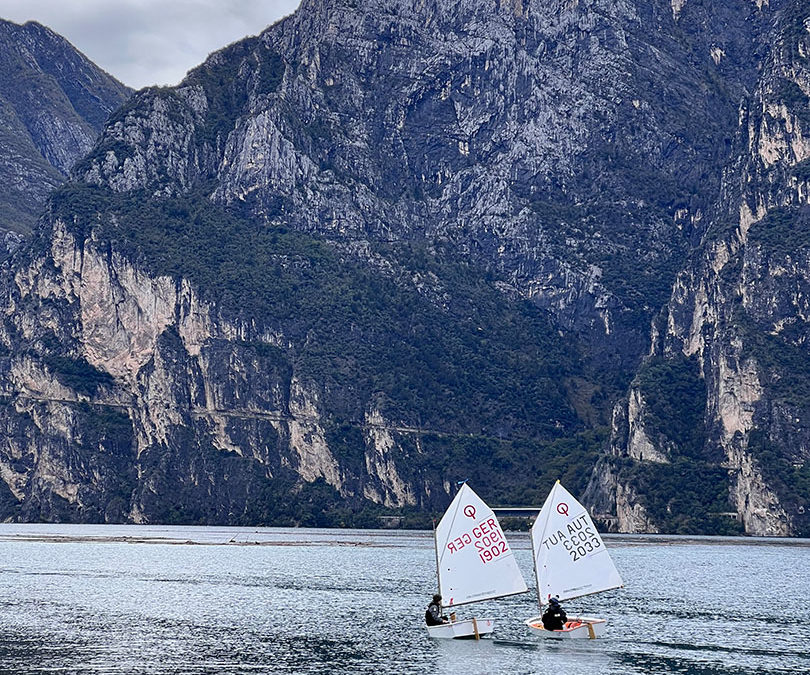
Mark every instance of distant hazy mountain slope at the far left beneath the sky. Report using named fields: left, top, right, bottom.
left=0, top=19, right=131, bottom=252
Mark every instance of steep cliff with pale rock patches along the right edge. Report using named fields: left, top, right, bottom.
left=591, top=3, right=810, bottom=535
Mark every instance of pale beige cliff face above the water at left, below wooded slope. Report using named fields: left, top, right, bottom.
left=0, top=219, right=448, bottom=522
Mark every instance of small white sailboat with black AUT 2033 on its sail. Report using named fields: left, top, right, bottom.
left=526, top=481, right=623, bottom=639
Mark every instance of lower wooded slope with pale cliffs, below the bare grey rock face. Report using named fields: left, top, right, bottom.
left=0, top=172, right=578, bottom=524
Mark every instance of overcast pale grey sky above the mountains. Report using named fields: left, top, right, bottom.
left=0, top=0, right=299, bottom=89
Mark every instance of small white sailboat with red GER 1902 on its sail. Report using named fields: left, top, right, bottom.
left=427, top=483, right=528, bottom=639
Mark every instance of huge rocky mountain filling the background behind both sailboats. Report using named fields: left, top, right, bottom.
left=0, top=0, right=810, bottom=534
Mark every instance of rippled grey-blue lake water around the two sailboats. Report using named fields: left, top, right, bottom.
left=0, top=524, right=810, bottom=675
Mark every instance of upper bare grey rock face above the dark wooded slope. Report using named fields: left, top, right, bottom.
left=74, top=0, right=768, bottom=368
